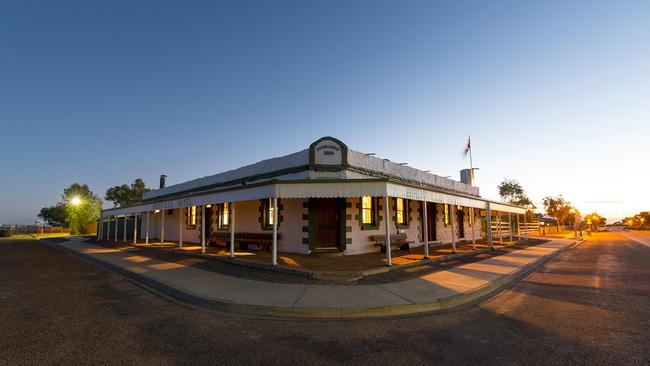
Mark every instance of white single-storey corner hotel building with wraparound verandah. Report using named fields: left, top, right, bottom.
left=98, top=137, right=525, bottom=264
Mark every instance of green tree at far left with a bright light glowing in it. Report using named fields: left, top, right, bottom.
left=61, top=183, right=102, bottom=235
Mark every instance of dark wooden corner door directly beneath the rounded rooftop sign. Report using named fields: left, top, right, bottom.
left=309, top=198, right=341, bottom=249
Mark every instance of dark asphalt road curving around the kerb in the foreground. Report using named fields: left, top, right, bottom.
left=0, top=233, right=650, bottom=365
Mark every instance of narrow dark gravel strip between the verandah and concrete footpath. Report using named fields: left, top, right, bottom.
left=85, top=238, right=547, bottom=285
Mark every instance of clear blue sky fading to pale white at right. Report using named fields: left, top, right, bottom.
left=0, top=0, right=650, bottom=224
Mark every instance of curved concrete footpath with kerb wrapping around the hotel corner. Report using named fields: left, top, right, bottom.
left=44, top=238, right=579, bottom=318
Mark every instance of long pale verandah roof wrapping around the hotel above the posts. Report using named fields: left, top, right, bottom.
left=102, top=179, right=525, bottom=216
